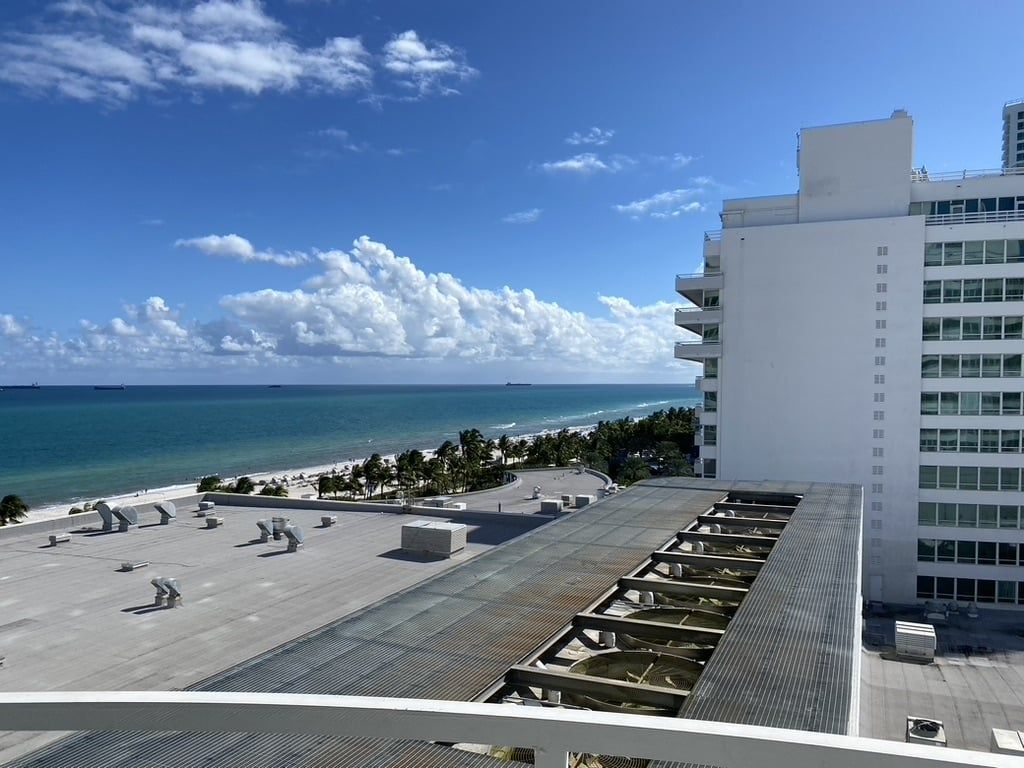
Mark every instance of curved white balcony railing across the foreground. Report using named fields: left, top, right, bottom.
left=0, top=691, right=1020, bottom=768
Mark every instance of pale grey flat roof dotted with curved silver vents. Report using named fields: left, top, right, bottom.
left=0, top=505, right=544, bottom=761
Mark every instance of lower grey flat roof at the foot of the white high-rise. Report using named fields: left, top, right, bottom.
left=860, top=608, right=1024, bottom=752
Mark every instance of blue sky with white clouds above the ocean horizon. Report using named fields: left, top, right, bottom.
left=0, top=0, right=1024, bottom=384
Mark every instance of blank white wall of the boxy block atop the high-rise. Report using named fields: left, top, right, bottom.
left=800, top=117, right=913, bottom=222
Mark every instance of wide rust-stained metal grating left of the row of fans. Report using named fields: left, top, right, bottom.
left=12, top=485, right=723, bottom=768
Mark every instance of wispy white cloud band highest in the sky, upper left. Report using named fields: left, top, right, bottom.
left=0, top=0, right=477, bottom=104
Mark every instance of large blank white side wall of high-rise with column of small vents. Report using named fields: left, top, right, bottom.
left=718, top=215, right=925, bottom=602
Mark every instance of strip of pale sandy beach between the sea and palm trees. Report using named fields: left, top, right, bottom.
left=17, top=424, right=597, bottom=524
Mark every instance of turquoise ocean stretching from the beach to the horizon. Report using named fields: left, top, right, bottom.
left=0, top=385, right=697, bottom=507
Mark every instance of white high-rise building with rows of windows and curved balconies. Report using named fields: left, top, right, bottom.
left=676, top=105, right=1024, bottom=606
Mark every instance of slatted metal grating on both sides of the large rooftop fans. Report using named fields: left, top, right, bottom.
left=13, top=478, right=861, bottom=768
